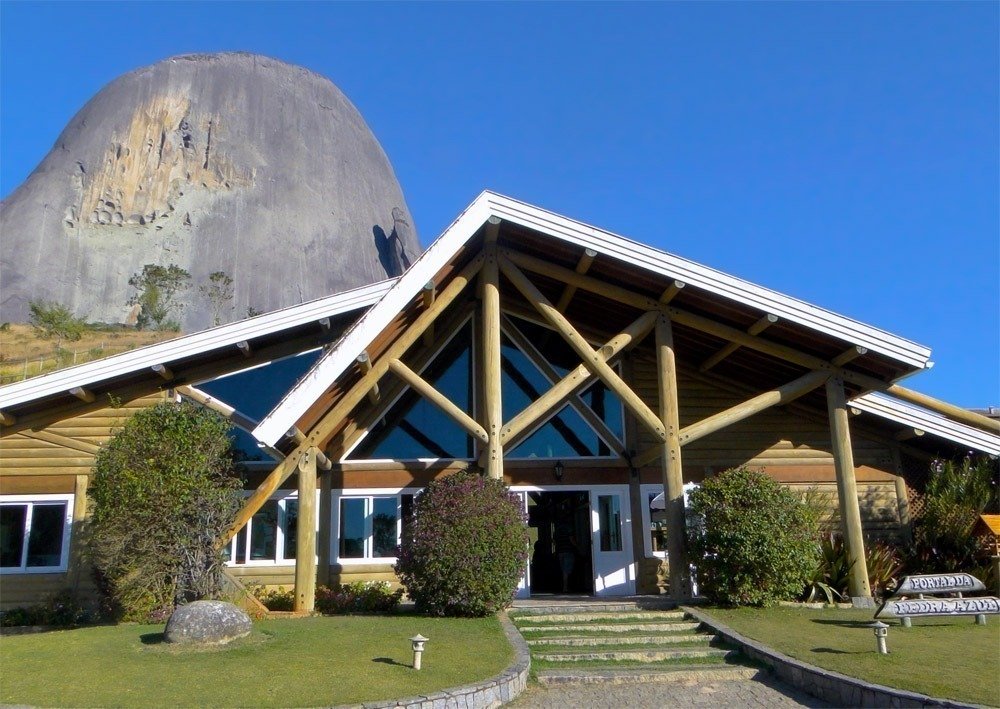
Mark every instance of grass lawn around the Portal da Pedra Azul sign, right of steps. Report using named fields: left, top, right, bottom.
left=703, top=608, right=1000, bottom=706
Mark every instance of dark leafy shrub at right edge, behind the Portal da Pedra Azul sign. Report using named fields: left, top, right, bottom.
left=908, top=455, right=1000, bottom=573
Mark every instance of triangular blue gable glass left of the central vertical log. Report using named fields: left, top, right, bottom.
left=348, top=323, right=472, bottom=460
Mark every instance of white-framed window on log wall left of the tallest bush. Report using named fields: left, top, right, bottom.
left=0, top=496, right=71, bottom=573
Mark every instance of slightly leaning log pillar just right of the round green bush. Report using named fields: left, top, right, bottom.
left=826, top=377, right=872, bottom=605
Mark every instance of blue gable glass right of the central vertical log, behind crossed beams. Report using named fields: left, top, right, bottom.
left=501, top=320, right=623, bottom=458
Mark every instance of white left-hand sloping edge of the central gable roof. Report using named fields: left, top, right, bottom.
left=253, top=192, right=490, bottom=445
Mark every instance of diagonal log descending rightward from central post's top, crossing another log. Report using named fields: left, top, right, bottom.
left=500, top=258, right=666, bottom=441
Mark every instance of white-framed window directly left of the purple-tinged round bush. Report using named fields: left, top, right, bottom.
left=337, top=494, right=413, bottom=561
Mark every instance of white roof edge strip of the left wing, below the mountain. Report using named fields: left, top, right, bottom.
left=0, top=279, right=395, bottom=409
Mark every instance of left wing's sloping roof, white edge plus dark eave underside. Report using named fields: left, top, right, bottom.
left=0, top=279, right=395, bottom=428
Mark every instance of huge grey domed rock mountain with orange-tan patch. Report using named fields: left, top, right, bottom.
left=0, top=53, right=419, bottom=332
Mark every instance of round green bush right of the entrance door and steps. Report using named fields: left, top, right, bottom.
left=689, top=468, right=817, bottom=606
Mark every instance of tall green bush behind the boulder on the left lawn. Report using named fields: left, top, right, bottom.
left=88, top=403, right=242, bottom=620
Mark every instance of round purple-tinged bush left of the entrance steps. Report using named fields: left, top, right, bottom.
left=396, top=471, right=528, bottom=616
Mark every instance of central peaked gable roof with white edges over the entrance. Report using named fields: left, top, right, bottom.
left=254, top=191, right=930, bottom=444
